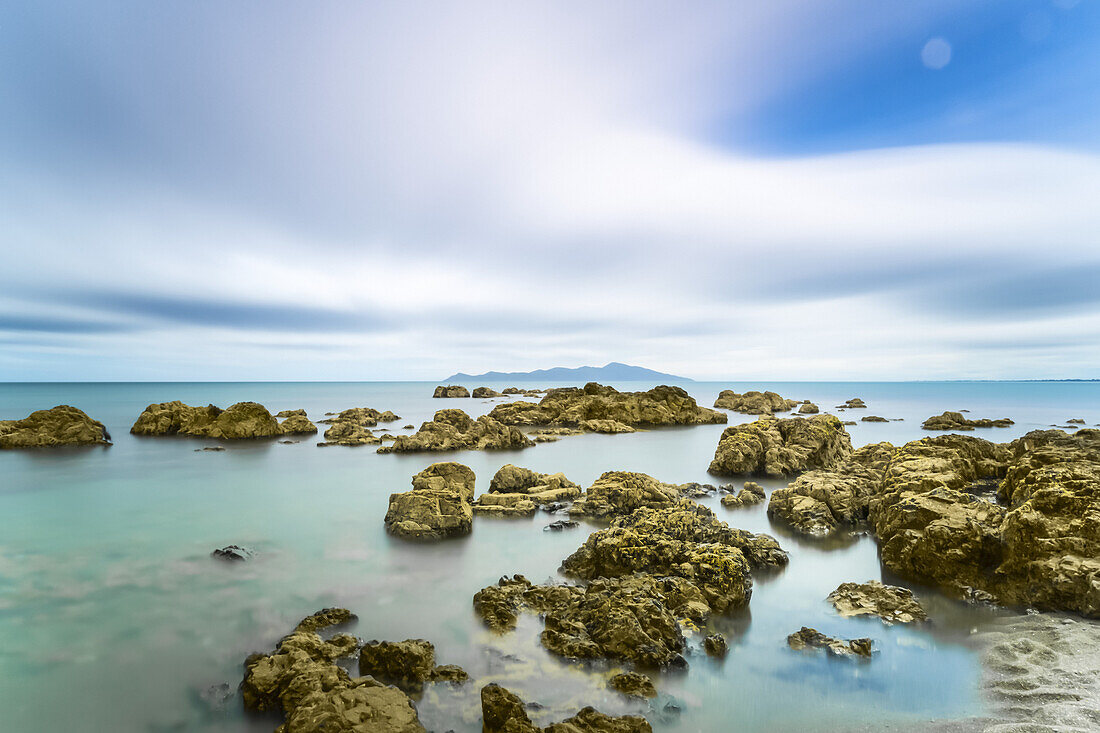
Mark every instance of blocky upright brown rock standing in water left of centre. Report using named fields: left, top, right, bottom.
left=385, top=462, right=474, bottom=540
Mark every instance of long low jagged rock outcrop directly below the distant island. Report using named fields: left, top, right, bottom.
left=490, top=382, right=726, bottom=429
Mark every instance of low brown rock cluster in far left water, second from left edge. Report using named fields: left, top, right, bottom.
left=130, top=400, right=317, bottom=440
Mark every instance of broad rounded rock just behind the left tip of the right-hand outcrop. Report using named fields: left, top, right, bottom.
left=708, top=415, right=851, bottom=477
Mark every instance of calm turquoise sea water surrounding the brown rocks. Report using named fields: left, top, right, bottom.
left=0, top=382, right=1100, bottom=732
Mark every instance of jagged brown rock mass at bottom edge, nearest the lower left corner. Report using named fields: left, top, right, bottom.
left=241, top=609, right=425, bottom=733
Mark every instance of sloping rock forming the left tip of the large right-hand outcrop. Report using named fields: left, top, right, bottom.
left=768, top=442, right=894, bottom=536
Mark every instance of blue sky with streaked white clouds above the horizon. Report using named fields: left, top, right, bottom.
left=0, top=0, right=1100, bottom=381
